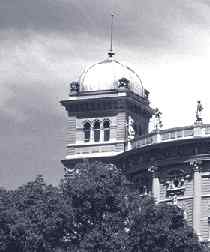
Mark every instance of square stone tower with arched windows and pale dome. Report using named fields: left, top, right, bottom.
left=61, top=53, right=152, bottom=168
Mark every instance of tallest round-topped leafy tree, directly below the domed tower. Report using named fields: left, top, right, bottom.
left=64, top=162, right=132, bottom=251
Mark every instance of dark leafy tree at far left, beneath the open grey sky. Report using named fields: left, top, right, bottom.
left=0, top=176, right=72, bottom=252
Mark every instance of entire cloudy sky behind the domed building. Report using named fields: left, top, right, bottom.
left=0, top=0, right=210, bottom=189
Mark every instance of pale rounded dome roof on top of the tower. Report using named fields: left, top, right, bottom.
left=79, top=58, right=145, bottom=96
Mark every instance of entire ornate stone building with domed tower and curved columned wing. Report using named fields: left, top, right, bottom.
left=61, top=51, right=210, bottom=241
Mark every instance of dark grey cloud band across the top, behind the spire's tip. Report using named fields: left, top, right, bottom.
left=0, top=0, right=209, bottom=47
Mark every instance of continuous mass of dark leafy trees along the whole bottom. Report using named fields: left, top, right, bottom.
left=0, top=161, right=207, bottom=252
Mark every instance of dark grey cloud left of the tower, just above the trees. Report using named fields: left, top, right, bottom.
left=0, top=83, right=66, bottom=188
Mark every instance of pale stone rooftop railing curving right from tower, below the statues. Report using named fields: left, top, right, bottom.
left=131, top=124, right=210, bottom=149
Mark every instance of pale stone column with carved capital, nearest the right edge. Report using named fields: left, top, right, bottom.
left=190, top=160, right=201, bottom=237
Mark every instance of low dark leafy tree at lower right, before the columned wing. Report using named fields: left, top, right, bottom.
left=128, top=199, right=206, bottom=252
